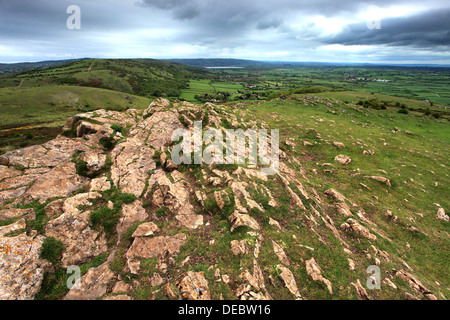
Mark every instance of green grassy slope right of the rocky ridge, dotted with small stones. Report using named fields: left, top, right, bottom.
left=244, top=96, right=450, bottom=298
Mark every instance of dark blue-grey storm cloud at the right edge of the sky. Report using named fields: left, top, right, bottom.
left=322, top=9, right=450, bottom=48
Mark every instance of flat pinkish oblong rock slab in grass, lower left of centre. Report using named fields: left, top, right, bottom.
left=127, top=233, right=186, bottom=259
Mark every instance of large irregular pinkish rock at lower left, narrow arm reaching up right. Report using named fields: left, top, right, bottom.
left=45, top=193, right=108, bottom=267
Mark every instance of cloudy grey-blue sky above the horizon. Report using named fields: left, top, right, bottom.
left=0, top=0, right=450, bottom=64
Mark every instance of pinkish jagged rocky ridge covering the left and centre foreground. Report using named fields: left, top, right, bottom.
left=0, top=99, right=449, bottom=300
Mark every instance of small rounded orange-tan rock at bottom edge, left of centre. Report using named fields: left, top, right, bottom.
left=178, top=271, right=211, bottom=300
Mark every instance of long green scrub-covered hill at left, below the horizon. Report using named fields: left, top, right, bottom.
left=0, top=59, right=204, bottom=97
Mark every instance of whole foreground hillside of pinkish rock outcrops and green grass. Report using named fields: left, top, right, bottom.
left=0, top=94, right=450, bottom=300
